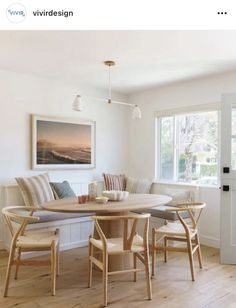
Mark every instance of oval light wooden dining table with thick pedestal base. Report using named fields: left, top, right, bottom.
left=42, top=194, right=171, bottom=270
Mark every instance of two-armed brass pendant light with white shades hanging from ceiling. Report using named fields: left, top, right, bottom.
left=73, top=60, right=142, bottom=119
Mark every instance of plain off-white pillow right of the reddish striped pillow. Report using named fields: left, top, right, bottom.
left=126, top=177, right=152, bottom=194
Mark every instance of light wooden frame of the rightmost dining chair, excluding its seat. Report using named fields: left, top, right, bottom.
left=152, top=202, right=206, bottom=281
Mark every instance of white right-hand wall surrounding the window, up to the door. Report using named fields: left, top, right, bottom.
left=128, top=73, right=236, bottom=247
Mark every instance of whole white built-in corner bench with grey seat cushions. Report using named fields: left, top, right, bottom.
left=0, top=181, right=196, bottom=250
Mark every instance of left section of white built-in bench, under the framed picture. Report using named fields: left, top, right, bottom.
left=0, top=183, right=93, bottom=250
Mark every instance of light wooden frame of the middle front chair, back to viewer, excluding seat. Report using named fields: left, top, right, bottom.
left=88, top=214, right=152, bottom=306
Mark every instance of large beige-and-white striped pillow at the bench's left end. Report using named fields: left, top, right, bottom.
left=16, top=173, right=54, bottom=207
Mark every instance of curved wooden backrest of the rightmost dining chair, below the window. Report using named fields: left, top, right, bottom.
left=173, top=202, right=206, bottom=232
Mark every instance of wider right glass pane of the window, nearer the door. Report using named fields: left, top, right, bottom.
left=177, top=111, right=218, bottom=185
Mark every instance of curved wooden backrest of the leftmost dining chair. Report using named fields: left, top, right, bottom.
left=2, top=206, right=40, bottom=243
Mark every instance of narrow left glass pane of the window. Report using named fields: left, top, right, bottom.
left=160, top=117, right=174, bottom=180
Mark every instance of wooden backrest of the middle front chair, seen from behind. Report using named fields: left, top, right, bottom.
left=92, top=213, right=151, bottom=250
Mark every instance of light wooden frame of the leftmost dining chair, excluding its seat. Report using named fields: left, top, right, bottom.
left=2, top=206, right=59, bottom=297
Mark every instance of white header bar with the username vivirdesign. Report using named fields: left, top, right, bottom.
left=0, top=0, right=236, bottom=30
